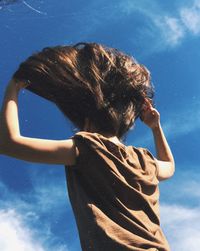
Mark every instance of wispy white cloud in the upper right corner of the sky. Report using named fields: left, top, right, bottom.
left=119, top=0, right=200, bottom=50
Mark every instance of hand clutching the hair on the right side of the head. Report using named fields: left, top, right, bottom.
left=140, top=99, right=160, bottom=129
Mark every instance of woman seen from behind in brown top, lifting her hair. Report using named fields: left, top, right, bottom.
left=0, top=43, right=175, bottom=251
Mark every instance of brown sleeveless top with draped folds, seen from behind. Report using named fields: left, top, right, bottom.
left=66, top=131, right=170, bottom=251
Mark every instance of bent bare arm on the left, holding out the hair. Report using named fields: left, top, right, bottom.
left=0, top=80, right=77, bottom=165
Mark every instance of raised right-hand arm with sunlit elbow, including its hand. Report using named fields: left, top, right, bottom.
left=141, top=100, right=175, bottom=180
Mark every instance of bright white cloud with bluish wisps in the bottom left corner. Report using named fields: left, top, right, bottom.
left=0, top=165, right=68, bottom=251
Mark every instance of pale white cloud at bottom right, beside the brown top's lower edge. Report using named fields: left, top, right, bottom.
left=161, top=204, right=200, bottom=251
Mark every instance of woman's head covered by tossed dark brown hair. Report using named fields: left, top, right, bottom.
left=14, top=43, right=153, bottom=138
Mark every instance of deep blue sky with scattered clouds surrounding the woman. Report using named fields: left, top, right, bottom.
left=0, top=0, right=200, bottom=251
